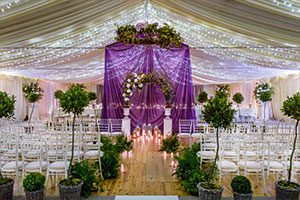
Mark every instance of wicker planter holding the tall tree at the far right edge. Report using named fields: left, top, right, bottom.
left=275, top=181, right=300, bottom=200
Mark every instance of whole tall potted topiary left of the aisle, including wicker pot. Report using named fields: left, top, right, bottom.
left=58, top=84, right=90, bottom=200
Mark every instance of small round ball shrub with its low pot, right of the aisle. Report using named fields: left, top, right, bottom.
left=231, top=176, right=253, bottom=200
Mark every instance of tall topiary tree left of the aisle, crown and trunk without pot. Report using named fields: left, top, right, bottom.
left=55, top=84, right=90, bottom=179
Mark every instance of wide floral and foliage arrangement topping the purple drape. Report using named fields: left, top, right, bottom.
left=115, top=23, right=183, bottom=49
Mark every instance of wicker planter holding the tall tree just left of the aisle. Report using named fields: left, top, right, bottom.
left=57, top=181, right=83, bottom=200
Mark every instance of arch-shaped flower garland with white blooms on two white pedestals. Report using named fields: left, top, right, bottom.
left=123, top=73, right=175, bottom=108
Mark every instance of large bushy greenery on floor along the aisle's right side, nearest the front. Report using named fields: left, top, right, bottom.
left=174, top=143, right=217, bottom=196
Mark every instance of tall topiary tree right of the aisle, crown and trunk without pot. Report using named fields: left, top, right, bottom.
left=203, top=92, right=236, bottom=186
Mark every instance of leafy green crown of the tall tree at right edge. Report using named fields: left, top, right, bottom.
left=281, top=92, right=300, bottom=120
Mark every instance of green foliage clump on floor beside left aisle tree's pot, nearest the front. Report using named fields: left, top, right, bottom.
left=71, top=160, right=100, bottom=198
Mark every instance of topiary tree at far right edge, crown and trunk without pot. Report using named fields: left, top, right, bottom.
left=281, top=92, right=300, bottom=182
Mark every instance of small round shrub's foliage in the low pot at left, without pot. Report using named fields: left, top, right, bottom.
left=23, top=172, right=46, bottom=192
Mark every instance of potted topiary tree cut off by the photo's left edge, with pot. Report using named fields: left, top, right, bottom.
left=0, top=91, right=16, bottom=200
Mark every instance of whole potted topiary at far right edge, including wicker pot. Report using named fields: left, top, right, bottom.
left=275, top=92, right=300, bottom=200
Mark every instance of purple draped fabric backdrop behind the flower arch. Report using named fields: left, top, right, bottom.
left=101, top=42, right=195, bottom=131
